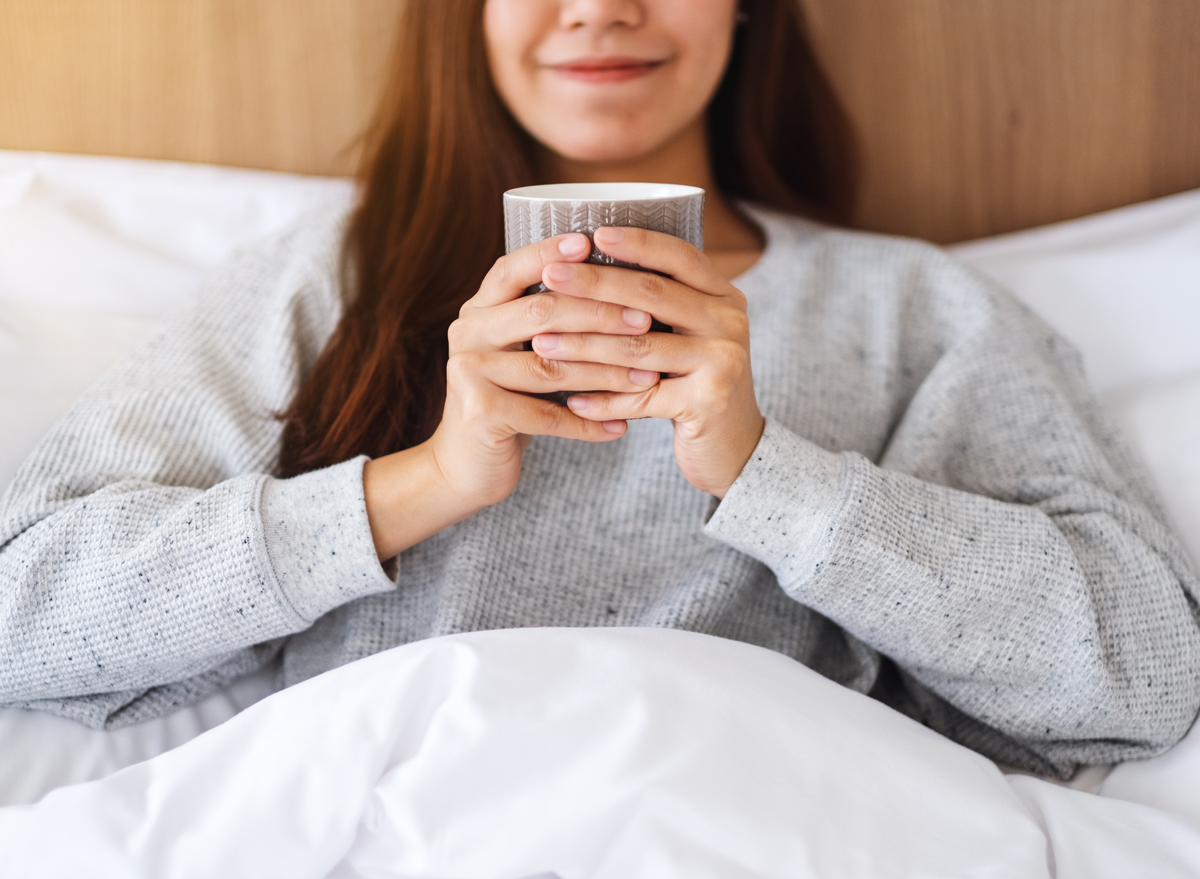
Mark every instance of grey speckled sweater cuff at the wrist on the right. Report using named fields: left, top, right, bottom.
left=704, top=419, right=847, bottom=588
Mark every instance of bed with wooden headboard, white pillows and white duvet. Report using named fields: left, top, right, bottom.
left=0, top=0, right=1200, bottom=879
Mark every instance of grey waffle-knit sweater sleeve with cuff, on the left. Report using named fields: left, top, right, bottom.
left=0, top=214, right=395, bottom=726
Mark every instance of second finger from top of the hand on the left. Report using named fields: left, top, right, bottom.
left=452, top=293, right=650, bottom=351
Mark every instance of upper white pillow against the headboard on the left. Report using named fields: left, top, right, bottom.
left=0, top=151, right=353, bottom=316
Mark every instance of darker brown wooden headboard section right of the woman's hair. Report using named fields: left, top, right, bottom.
left=803, top=0, right=1200, bottom=241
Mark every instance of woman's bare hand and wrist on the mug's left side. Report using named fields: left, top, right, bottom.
left=362, top=233, right=659, bottom=560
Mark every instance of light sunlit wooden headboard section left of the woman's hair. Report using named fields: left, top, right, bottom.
left=0, top=0, right=398, bottom=174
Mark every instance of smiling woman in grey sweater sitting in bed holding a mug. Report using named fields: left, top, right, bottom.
left=0, top=0, right=1200, bottom=775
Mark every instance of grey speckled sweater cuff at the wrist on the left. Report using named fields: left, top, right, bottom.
left=260, top=456, right=398, bottom=623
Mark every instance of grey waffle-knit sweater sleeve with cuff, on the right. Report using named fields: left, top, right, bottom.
left=707, top=259, right=1200, bottom=775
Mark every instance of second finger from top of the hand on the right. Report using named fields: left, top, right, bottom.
left=542, top=263, right=731, bottom=335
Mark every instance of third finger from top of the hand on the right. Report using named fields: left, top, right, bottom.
left=533, top=333, right=713, bottom=375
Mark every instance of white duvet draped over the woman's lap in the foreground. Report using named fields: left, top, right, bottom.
left=7, top=629, right=1200, bottom=879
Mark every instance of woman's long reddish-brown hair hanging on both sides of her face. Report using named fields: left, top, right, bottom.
left=278, top=0, right=856, bottom=476
